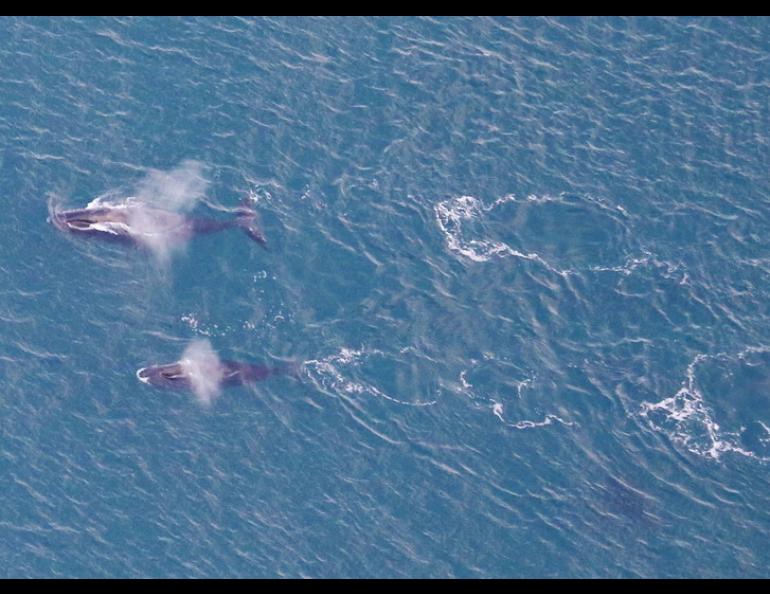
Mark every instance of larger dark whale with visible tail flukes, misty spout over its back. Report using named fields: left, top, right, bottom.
left=49, top=198, right=267, bottom=247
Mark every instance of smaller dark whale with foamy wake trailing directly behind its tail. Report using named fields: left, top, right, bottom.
left=136, top=361, right=294, bottom=390
